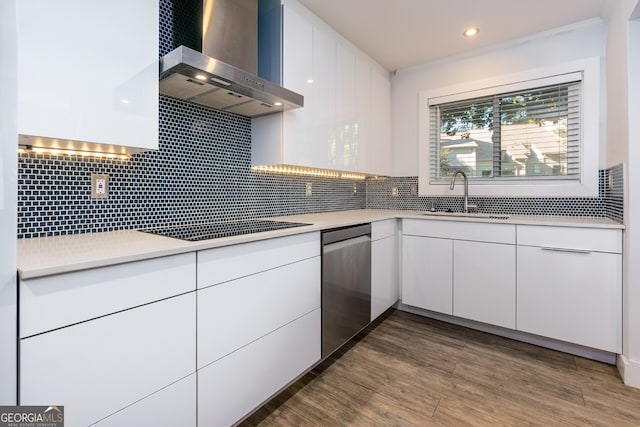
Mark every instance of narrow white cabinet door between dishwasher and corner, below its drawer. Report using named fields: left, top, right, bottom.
left=371, top=237, right=399, bottom=321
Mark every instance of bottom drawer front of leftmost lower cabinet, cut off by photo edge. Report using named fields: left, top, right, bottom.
left=94, top=372, right=197, bottom=427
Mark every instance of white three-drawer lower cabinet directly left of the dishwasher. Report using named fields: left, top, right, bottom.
left=197, top=233, right=321, bottom=426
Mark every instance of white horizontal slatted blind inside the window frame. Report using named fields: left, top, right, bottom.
left=428, top=81, right=581, bottom=182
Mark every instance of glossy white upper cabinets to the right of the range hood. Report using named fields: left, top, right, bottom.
left=252, top=0, right=391, bottom=175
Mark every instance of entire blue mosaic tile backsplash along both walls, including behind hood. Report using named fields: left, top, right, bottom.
left=17, top=0, right=624, bottom=238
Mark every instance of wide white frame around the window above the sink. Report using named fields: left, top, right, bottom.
left=418, top=57, right=601, bottom=197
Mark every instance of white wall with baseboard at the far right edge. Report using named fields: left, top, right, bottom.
left=607, top=0, right=640, bottom=387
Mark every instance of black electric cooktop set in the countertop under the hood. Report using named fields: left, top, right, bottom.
left=141, top=219, right=309, bottom=242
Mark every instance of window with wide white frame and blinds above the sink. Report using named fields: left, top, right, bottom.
left=419, top=58, right=601, bottom=196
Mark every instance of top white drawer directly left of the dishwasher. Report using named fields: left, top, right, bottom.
left=198, top=233, right=320, bottom=288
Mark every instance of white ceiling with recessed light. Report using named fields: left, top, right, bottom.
left=299, top=0, right=615, bottom=71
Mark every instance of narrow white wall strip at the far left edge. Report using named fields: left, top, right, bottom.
left=0, top=0, right=18, bottom=405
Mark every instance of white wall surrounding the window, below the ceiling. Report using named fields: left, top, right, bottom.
left=391, top=20, right=607, bottom=176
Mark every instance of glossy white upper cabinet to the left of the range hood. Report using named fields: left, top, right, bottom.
left=18, top=0, right=159, bottom=153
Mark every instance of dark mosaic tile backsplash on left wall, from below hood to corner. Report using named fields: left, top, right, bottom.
left=18, top=97, right=366, bottom=238
